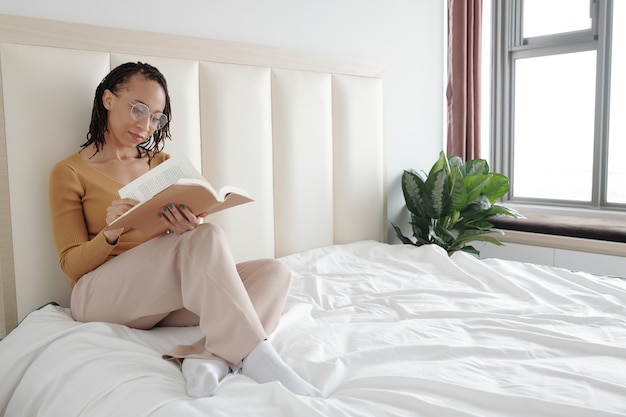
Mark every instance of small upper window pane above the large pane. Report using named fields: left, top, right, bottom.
left=522, top=0, right=591, bottom=38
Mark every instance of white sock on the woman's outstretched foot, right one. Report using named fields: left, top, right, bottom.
left=241, top=340, right=324, bottom=397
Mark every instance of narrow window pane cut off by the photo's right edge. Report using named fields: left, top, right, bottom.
left=607, top=1, right=626, bottom=203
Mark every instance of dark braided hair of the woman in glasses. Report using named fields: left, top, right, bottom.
left=81, top=62, right=172, bottom=157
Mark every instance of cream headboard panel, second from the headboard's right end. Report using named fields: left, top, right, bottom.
left=272, top=70, right=333, bottom=253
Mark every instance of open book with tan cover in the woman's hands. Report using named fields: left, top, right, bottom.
left=106, top=157, right=253, bottom=236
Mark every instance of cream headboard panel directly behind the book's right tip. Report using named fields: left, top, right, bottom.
left=200, top=62, right=274, bottom=259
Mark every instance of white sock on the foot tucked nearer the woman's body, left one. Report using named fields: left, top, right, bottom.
left=182, top=358, right=229, bottom=398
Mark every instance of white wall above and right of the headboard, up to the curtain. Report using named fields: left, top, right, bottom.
left=0, top=0, right=444, bottom=241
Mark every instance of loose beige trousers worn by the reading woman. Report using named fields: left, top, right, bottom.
left=71, top=223, right=291, bottom=369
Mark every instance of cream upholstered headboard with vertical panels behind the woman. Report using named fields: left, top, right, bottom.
left=0, top=15, right=387, bottom=334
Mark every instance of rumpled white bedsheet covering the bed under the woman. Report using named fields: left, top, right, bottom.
left=0, top=241, right=626, bottom=417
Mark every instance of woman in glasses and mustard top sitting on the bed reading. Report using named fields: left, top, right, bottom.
left=49, top=62, right=321, bottom=397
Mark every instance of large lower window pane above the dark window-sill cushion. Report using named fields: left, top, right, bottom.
left=512, top=51, right=596, bottom=202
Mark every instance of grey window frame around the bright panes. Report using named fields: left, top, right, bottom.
left=490, top=0, right=626, bottom=211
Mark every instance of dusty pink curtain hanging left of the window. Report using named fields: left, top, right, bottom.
left=446, top=0, right=483, bottom=161
